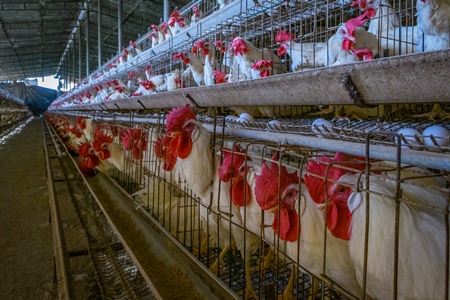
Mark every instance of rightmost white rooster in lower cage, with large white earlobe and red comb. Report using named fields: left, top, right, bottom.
left=305, top=153, right=448, bottom=299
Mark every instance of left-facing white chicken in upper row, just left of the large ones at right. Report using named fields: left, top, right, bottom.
left=275, top=30, right=325, bottom=72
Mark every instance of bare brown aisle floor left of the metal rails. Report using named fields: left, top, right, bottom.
left=0, top=118, right=55, bottom=299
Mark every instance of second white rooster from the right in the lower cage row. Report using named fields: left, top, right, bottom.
left=254, top=153, right=368, bottom=297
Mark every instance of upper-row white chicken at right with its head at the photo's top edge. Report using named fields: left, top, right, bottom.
left=352, top=0, right=419, bottom=56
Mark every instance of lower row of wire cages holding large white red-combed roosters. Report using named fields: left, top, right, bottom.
left=46, top=107, right=450, bottom=299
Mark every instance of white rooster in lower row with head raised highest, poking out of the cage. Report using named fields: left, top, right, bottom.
left=166, top=106, right=258, bottom=295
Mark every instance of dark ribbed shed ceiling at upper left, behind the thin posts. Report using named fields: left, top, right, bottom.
left=0, top=0, right=189, bottom=81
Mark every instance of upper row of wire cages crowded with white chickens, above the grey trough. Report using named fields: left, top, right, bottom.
left=53, top=0, right=442, bottom=107
